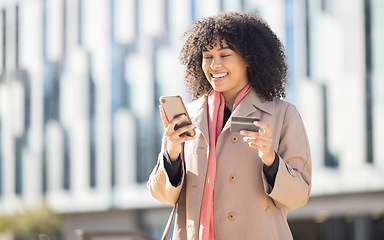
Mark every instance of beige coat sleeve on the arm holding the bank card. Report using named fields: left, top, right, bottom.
left=262, top=105, right=312, bottom=209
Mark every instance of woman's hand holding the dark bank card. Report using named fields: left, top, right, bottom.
left=240, top=121, right=275, bottom=166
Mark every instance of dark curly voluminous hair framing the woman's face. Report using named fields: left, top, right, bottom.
left=180, top=12, right=288, bottom=101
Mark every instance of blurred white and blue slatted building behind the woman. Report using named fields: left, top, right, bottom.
left=0, top=0, right=384, bottom=240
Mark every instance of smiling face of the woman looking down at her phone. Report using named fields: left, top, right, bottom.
left=202, top=40, right=249, bottom=103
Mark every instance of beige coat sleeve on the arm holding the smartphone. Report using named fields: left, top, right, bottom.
left=147, top=137, right=185, bottom=205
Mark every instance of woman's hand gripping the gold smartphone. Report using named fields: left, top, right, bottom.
left=159, top=105, right=196, bottom=161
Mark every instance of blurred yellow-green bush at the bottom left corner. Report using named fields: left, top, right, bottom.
left=0, top=205, right=62, bottom=240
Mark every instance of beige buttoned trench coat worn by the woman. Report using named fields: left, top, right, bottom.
left=148, top=91, right=311, bottom=240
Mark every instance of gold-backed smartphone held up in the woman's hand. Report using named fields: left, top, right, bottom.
left=159, top=96, right=196, bottom=137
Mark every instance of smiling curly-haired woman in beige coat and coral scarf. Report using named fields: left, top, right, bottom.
left=148, top=13, right=311, bottom=240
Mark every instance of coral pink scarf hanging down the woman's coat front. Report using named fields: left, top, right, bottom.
left=199, top=84, right=252, bottom=240
